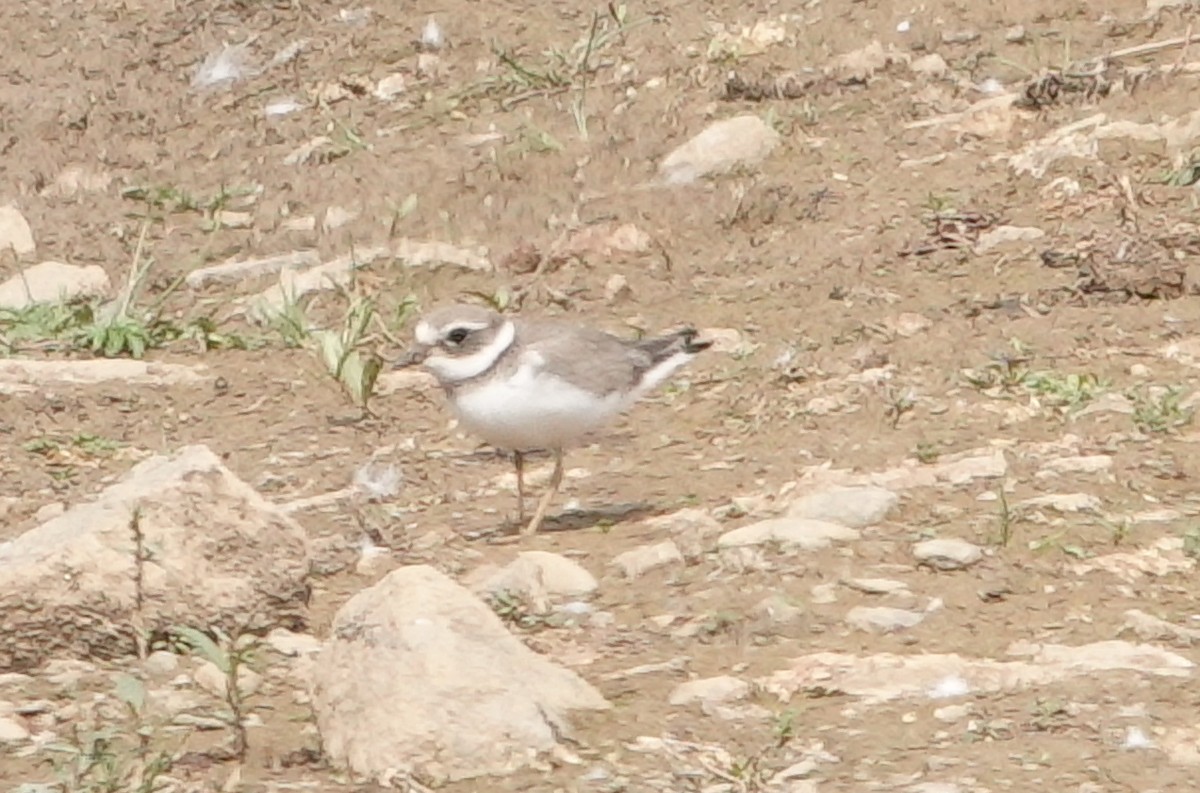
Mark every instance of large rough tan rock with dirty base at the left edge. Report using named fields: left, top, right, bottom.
left=0, top=446, right=308, bottom=671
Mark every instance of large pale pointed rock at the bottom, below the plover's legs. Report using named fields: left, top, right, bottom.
left=313, top=565, right=608, bottom=783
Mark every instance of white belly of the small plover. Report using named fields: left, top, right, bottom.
left=454, top=366, right=628, bottom=451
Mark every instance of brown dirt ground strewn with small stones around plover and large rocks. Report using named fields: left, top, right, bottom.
left=0, top=0, right=1200, bottom=791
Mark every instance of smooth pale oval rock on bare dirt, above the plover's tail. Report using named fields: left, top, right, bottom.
left=659, top=114, right=780, bottom=185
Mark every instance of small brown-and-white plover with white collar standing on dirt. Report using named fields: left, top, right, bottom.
left=396, top=304, right=712, bottom=534
